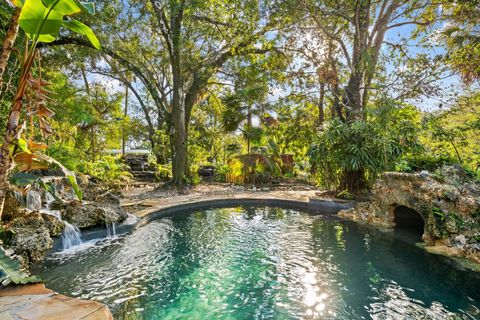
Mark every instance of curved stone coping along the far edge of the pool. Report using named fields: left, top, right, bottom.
left=120, top=190, right=354, bottom=222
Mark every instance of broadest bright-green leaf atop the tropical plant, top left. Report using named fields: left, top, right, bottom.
left=18, top=0, right=63, bottom=42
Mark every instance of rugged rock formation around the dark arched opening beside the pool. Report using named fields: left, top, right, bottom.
left=338, top=166, right=480, bottom=261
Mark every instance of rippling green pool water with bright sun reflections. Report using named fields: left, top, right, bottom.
left=35, top=207, right=480, bottom=319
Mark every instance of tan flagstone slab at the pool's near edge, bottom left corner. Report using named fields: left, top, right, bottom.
left=0, top=283, right=113, bottom=320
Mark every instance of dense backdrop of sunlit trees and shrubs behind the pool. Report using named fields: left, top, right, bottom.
left=0, top=0, right=480, bottom=192
